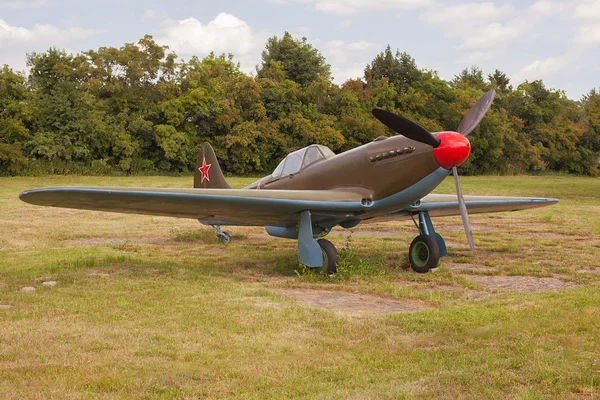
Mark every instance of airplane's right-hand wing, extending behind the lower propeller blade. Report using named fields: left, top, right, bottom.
left=384, top=194, right=558, bottom=219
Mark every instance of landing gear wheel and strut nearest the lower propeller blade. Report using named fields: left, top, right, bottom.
left=408, top=211, right=447, bottom=274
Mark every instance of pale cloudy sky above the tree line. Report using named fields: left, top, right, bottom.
left=0, top=0, right=600, bottom=100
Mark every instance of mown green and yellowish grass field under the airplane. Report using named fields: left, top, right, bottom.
left=0, top=176, right=600, bottom=399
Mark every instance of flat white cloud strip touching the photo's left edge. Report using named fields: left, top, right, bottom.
left=0, top=19, right=99, bottom=48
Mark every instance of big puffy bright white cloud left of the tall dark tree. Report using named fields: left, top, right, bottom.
left=156, top=13, right=267, bottom=72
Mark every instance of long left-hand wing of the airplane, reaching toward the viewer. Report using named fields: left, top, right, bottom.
left=19, top=187, right=363, bottom=226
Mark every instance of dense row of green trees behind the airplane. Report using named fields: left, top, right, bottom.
left=0, top=33, right=600, bottom=176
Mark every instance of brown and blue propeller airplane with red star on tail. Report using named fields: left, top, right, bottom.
left=19, top=90, right=558, bottom=274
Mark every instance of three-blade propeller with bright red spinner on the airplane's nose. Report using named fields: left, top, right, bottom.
left=373, top=90, right=496, bottom=250
